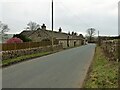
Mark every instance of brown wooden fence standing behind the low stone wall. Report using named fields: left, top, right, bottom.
left=1, top=41, right=58, bottom=51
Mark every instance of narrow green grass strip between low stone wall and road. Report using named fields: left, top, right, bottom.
left=2, top=52, right=52, bottom=67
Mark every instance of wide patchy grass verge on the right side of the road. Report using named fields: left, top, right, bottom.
left=83, top=47, right=118, bottom=88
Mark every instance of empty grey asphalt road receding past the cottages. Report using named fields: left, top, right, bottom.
left=2, top=44, right=95, bottom=88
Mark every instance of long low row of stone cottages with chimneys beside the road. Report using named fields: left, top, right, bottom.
left=20, top=24, right=84, bottom=48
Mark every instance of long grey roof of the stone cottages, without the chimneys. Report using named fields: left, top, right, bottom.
left=21, top=28, right=82, bottom=39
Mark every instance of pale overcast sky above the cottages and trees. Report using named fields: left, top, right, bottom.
left=0, top=0, right=119, bottom=35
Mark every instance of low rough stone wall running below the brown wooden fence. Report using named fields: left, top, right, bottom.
left=2, top=45, right=62, bottom=60
